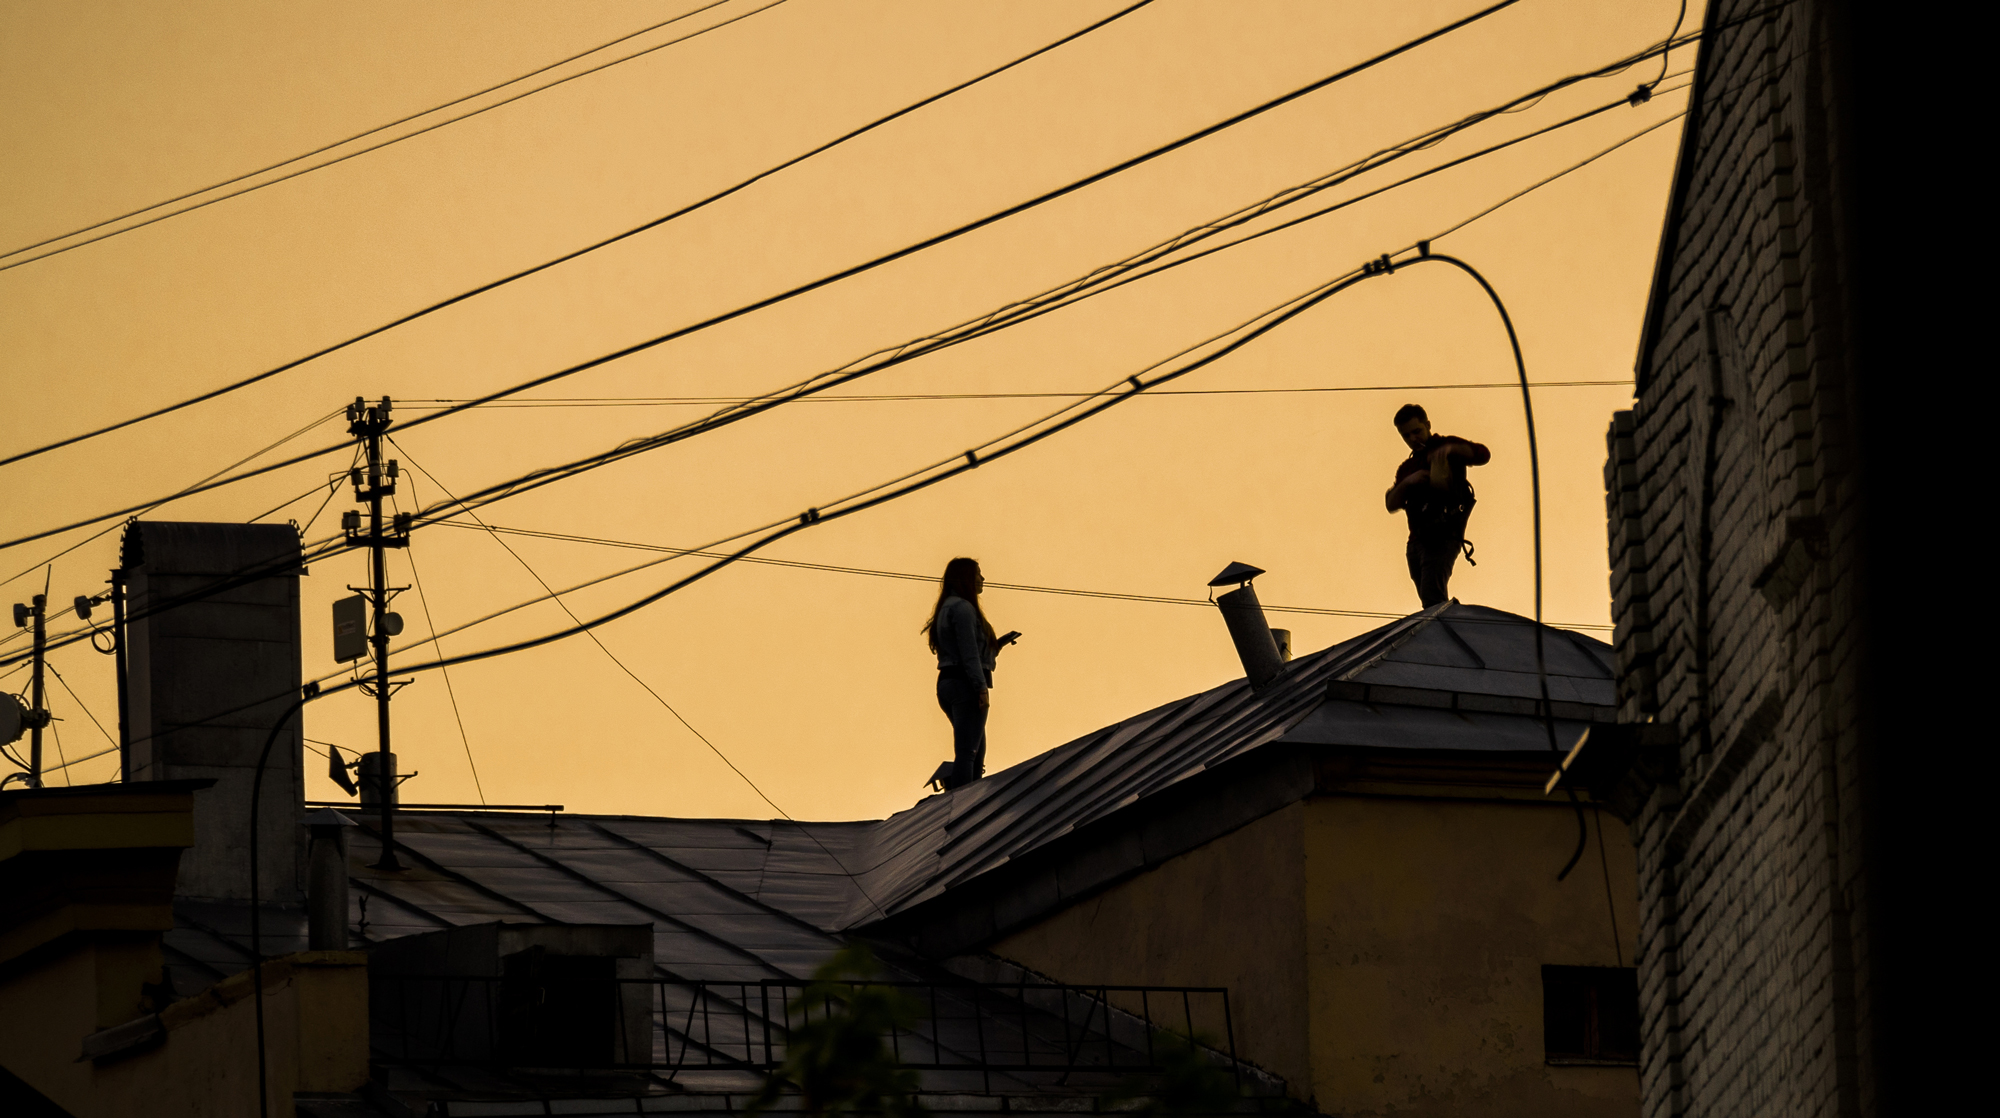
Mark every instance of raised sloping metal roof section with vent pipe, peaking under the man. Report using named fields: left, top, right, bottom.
left=812, top=602, right=1616, bottom=928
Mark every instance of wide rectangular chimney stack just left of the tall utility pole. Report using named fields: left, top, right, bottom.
left=122, top=520, right=306, bottom=906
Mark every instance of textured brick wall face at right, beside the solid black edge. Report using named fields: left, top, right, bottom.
left=1604, top=0, right=1876, bottom=1118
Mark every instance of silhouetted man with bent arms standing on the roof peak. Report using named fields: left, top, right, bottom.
left=1384, top=404, right=1492, bottom=610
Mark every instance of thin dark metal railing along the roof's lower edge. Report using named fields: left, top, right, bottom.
left=370, top=976, right=1236, bottom=1086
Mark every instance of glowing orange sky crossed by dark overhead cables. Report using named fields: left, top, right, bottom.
left=0, top=0, right=1692, bottom=818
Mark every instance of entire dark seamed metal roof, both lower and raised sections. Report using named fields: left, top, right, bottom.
left=145, top=602, right=1614, bottom=1114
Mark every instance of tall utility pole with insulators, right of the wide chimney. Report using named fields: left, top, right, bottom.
left=340, top=396, right=410, bottom=870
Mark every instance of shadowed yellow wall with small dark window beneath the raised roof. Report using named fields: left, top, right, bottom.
left=992, top=772, right=1638, bottom=1118
